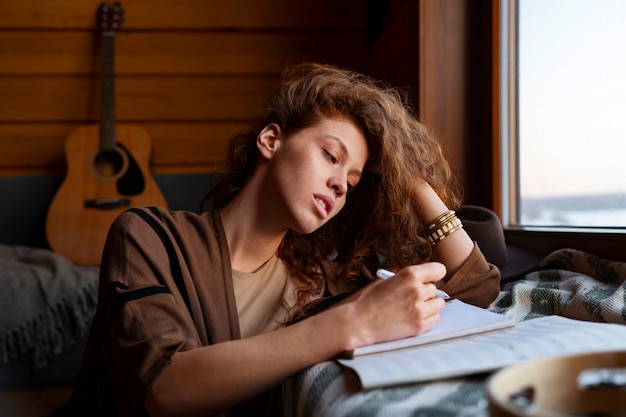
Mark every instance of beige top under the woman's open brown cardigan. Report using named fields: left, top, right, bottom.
left=233, top=255, right=295, bottom=337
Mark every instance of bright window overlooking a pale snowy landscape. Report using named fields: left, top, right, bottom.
left=500, top=0, right=626, bottom=228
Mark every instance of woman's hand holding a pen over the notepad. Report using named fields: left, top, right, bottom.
left=344, top=262, right=446, bottom=348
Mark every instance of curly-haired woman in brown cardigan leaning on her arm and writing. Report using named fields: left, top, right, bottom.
left=53, top=64, right=499, bottom=416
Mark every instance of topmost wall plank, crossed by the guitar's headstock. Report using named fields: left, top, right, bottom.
left=0, top=0, right=365, bottom=31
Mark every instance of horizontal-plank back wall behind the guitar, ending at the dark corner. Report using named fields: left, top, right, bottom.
left=0, top=0, right=368, bottom=175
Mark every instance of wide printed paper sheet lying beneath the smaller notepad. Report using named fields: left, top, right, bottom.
left=338, top=316, right=626, bottom=389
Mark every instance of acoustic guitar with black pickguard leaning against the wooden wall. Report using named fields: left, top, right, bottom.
left=46, top=3, right=166, bottom=265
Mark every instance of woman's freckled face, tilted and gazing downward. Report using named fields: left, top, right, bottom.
left=260, top=118, right=368, bottom=233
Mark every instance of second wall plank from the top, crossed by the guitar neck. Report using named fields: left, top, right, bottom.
left=0, top=30, right=366, bottom=76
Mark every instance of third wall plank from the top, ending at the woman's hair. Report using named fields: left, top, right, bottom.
left=0, top=75, right=276, bottom=123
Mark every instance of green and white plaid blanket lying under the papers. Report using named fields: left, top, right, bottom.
left=283, top=249, right=626, bottom=417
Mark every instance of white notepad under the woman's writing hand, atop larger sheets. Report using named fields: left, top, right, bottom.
left=347, top=300, right=515, bottom=357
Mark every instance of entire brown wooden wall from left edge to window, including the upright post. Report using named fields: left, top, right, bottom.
left=0, top=0, right=493, bottom=207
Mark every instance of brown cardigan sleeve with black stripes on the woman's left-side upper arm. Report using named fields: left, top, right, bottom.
left=97, top=213, right=200, bottom=415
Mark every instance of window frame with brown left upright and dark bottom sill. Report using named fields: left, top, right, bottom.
left=493, top=0, right=626, bottom=261
